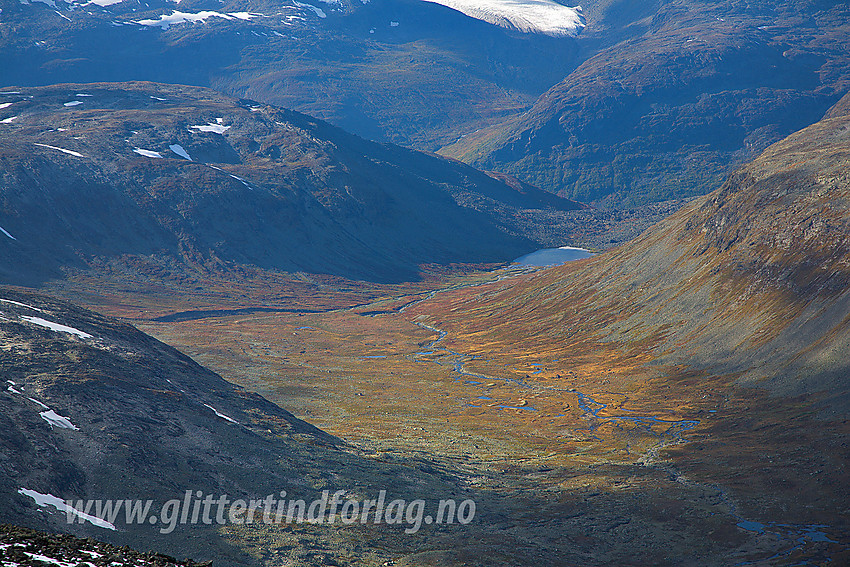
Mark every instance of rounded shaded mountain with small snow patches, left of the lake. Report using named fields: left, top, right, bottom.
left=0, top=83, right=582, bottom=284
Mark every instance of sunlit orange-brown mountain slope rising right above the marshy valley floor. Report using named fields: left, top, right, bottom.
left=430, top=90, right=850, bottom=412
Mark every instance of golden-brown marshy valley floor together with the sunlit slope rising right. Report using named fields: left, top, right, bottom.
left=8, top=93, right=850, bottom=565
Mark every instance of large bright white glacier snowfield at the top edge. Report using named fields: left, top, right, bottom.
left=418, top=0, right=585, bottom=37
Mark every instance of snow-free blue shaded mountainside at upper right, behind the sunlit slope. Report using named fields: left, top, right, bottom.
left=442, top=0, right=850, bottom=204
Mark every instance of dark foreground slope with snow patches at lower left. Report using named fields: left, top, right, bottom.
left=0, top=288, right=480, bottom=565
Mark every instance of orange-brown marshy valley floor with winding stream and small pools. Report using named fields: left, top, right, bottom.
left=43, top=270, right=850, bottom=565
